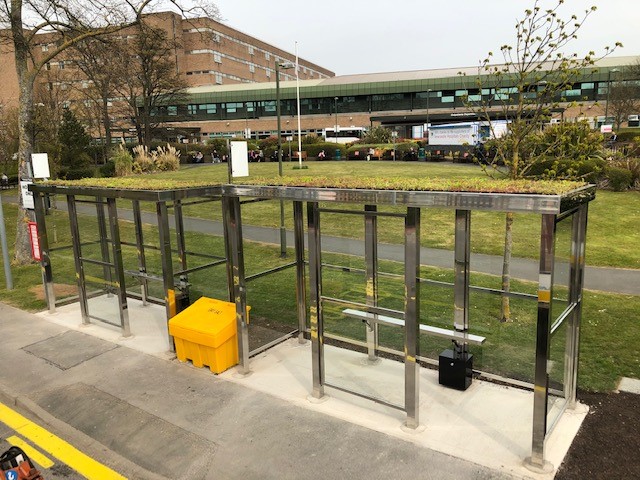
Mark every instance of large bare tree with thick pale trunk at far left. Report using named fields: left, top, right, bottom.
left=0, top=0, right=217, bottom=264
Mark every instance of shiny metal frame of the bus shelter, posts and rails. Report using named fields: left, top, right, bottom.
left=30, top=184, right=595, bottom=470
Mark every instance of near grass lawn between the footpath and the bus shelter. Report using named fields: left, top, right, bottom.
left=0, top=196, right=640, bottom=391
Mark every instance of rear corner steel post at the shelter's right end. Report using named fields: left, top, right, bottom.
left=565, top=203, right=589, bottom=408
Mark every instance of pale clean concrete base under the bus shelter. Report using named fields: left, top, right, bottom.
left=39, top=297, right=588, bottom=479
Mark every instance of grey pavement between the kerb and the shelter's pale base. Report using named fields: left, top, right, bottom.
left=0, top=303, right=524, bottom=480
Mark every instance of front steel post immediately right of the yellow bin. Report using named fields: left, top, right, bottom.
left=226, top=197, right=250, bottom=375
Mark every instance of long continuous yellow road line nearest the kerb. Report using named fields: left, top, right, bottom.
left=0, top=403, right=126, bottom=480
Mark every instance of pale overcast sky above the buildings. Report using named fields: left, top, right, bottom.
left=214, top=0, right=640, bottom=75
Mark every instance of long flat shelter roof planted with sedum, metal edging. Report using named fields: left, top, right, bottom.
left=29, top=177, right=595, bottom=214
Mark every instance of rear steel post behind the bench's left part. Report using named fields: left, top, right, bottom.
left=364, top=205, right=378, bottom=362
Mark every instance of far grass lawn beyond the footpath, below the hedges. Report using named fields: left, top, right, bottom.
left=138, top=162, right=640, bottom=269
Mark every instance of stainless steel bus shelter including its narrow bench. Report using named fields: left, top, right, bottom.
left=30, top=181, right=595, bottom=471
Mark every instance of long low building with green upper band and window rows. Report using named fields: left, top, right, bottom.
left=158, top=57, right=640, bottom=140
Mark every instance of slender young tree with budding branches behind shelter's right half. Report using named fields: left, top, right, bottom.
left=466, top=0, right=620, bottom=321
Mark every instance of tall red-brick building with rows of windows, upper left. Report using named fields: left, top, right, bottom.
left=0, top=12, right=334, bottom=111
